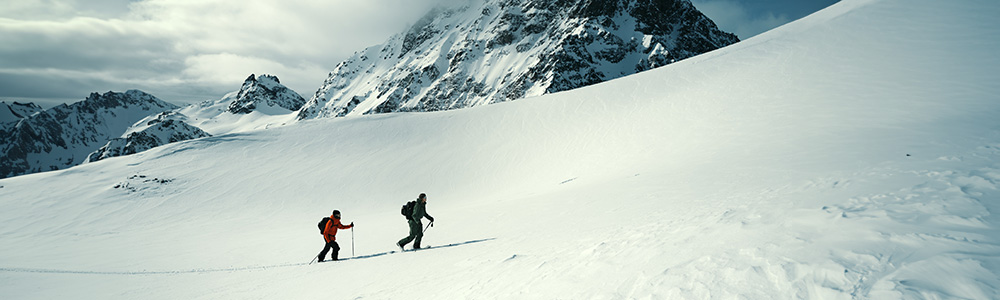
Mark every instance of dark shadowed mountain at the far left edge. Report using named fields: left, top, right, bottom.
left=0, top=90, right=178, bottom=178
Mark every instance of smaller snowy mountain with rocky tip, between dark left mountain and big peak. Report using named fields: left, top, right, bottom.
left=87, top=74, right=305, bottom=161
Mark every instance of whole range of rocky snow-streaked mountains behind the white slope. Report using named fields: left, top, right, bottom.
left=0, top=0, right=739, bottom=178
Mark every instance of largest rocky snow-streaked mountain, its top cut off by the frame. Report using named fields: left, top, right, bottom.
left=297, top=0, right=738, bottom=119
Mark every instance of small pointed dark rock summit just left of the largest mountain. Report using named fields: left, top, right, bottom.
left=229, top=74, right=306, bottom=114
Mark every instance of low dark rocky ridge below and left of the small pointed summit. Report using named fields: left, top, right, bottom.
left=87, top=112, right=212, bottom=162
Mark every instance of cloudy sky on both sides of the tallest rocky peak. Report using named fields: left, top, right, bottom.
left=0, top=0, right=837, bottom=108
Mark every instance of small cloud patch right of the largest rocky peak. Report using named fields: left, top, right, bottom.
left=692, top=0, right=791, bottom=40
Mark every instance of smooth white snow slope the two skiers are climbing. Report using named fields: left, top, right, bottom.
left=0, top=0, right=1000, bottom=299
